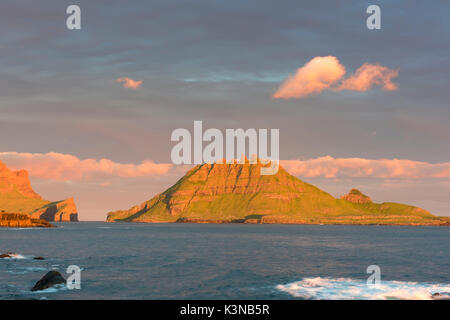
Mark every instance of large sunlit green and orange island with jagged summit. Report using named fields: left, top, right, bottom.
left=107, top=164, right=441, bottom=224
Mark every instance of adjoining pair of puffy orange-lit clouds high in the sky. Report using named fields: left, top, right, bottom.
left=272, top=56, right=399, bottom=99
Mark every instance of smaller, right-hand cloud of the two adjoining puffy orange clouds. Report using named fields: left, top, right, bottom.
left=339, top=63, right=398, bottom=91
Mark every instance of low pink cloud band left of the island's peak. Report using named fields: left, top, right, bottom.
left=0, top=152, right=172, bottom=181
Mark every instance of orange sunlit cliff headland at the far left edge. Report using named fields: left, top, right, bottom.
left=0, top=161, right=78, bottom=221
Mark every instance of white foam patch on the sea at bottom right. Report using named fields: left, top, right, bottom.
left=276, top=277, right=450, bottom=300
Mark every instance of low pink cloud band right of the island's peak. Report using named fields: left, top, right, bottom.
left=281, top=156, right=450, bottom=179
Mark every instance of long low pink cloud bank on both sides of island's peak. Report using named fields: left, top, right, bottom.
left=0, top=152, right=450, bottom=181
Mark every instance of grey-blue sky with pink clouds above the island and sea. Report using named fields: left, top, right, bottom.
left=0, top=0, right=450, bottom=220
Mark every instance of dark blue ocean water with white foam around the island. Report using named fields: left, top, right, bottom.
left=0, top=222, right=450, bottom=300
